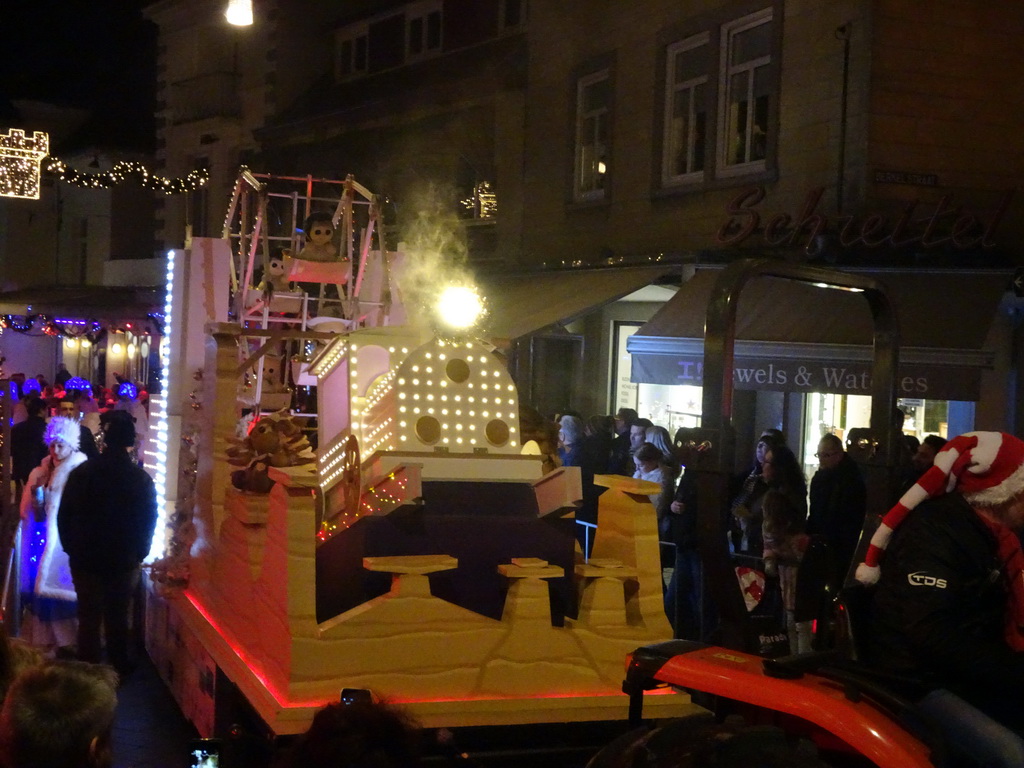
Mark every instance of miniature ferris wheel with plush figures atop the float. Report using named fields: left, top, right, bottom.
left=223, top=167, right=403, bottom=412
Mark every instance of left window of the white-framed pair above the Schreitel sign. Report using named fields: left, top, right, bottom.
left=662, top=32, right=710, bottom=185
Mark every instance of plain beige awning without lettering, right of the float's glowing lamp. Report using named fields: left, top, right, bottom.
left=479, top=265, right=679, bottom=343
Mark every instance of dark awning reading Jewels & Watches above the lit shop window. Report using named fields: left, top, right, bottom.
left=627, top=269, right=1010, bottom=400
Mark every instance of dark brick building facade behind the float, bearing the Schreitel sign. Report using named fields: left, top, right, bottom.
left=148, top=0, right=1024, bottom=442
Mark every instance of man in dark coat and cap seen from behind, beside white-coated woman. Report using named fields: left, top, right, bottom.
left=57, top=411, right=157, bottom=675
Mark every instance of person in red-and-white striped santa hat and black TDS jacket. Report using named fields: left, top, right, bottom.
left=868, top=432, right=1024, bottom=767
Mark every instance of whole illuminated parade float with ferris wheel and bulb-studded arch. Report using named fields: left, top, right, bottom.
left=145, top=170, right=695, bottom=735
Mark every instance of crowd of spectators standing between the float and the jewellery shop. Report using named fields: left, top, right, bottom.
left=536, top=408, right=945, bottom=652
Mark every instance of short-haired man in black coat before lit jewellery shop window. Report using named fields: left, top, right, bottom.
left=806, top=434, right=867, bottom=587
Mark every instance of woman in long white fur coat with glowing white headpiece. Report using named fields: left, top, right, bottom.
left=20, top=416, right=86, bottom=653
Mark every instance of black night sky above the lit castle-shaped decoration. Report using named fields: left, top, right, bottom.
left=0, top=0, right=156, bottom=150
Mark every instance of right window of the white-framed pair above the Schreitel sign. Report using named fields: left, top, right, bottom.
left=719, top=8, right=774, bottom=175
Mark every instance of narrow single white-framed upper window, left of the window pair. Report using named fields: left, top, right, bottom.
left=573, top=70, right=611, bottom=201
